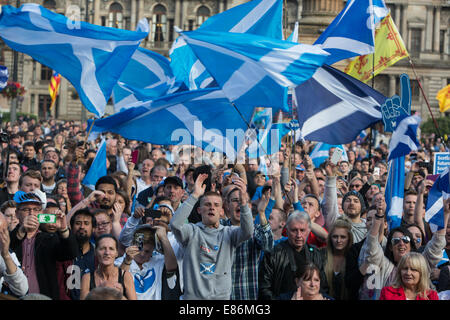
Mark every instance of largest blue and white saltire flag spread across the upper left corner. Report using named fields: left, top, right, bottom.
left=0, top=3, right=148, bottom=117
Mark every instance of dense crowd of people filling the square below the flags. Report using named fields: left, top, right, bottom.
left=0, top=118, right=450, bottom=300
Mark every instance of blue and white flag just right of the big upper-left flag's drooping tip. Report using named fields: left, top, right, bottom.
left=113, top=48, right=183, bottom=112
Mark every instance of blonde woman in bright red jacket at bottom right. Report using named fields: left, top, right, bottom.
left=380, top=252, right=439, bottom=300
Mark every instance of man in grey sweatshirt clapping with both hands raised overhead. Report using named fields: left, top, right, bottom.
left=170, top=174, right=253, bottom=300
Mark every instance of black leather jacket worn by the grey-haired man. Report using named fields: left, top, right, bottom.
left=258, top=240, right=328, bottom=300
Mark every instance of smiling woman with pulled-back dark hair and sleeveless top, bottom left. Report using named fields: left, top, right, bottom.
left=80, top=234, right=137, bottom=300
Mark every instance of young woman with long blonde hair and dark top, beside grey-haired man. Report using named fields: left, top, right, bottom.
left=322, top=216, right=353, bottom=300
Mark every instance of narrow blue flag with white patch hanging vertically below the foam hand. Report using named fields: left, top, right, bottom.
left=384, top=156, right=405, bottom=230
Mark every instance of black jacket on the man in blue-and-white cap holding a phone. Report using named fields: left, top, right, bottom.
left=10, top=225, right=79, bottom=300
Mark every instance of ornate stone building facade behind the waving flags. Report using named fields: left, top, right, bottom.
left=0, top=0, right=450, bottom=120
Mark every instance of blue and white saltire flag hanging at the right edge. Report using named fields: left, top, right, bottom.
left=425, top=167, right=450, bottom=232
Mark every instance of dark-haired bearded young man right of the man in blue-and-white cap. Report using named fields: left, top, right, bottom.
left=66, top=208, right=97, bottom=300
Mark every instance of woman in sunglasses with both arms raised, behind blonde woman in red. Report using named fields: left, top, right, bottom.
left=366, top=200, right=450, bottom=299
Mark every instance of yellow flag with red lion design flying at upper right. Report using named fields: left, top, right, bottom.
left=345, top=14, right=408, bottom=82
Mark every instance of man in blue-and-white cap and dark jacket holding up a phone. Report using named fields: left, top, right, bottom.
left=10, top=190, right=78, bottom=300
